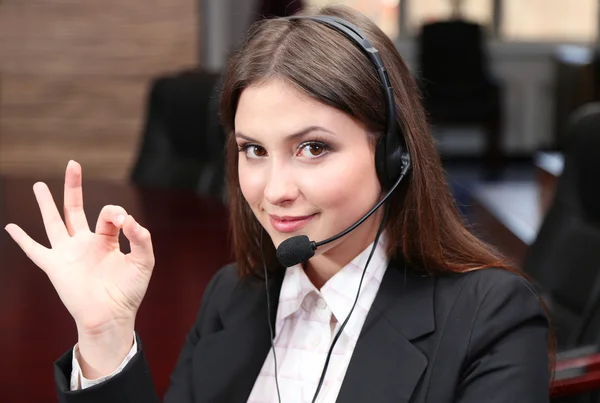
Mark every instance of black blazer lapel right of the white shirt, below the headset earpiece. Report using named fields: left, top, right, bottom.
left=337, top=262, right=435, bottom=403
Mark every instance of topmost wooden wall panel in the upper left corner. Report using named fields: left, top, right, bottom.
left=0, top=0, right=197, bottom=76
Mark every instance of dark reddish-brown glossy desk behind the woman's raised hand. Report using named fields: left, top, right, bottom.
left=0, top=176, right=232, bottom=403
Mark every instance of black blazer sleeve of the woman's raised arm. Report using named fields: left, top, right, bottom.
left=54, top=270, right=223, bottom=403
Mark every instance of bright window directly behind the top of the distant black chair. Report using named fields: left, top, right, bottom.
left=406, top=0, right=492, bottom=35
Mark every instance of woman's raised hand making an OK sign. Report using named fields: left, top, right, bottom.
left=6, top=161, right=154, bottom=340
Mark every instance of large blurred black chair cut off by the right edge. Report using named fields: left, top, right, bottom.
left=523, top=103, right=600, bottom=349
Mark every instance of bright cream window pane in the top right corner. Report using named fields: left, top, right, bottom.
left=502, top=0, right=598, bottom=42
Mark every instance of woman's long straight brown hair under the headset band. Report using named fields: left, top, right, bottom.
left=220, top=6, right=514, bottom=276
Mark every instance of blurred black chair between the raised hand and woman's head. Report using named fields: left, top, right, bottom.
left=131, top=70, right=225, bottom=198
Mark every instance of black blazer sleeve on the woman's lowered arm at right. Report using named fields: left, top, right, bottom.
left=455, top=275, right=550, bottom=403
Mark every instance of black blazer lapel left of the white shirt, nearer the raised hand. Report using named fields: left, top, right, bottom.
left=193, top=275, right=283, bottom=403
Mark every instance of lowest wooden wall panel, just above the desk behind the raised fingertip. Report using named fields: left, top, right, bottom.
left=0, top=117, right=140, bottom=181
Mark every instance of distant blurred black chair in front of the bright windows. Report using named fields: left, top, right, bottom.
left=419, top=18, right=504, bottom=176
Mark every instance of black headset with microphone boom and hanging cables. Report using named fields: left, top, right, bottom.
left=260, top=15, right=411, bottom=403
